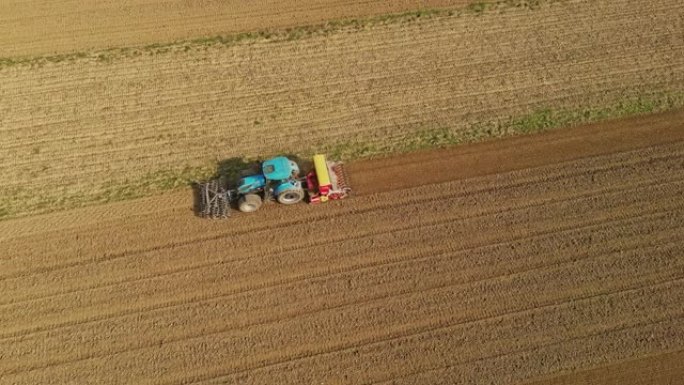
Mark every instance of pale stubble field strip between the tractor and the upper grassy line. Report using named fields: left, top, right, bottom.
left=0, top=0, right=684, bottom=218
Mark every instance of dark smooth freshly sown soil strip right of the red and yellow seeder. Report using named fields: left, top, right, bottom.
left=349, top=110, right=684, bottom=194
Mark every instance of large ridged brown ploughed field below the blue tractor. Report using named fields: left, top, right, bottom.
left=0, top=113, right=684, bottom=384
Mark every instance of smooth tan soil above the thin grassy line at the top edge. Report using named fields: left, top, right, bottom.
left=0, top=0, right=469, bottom=57
